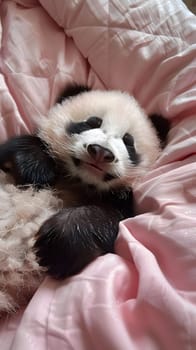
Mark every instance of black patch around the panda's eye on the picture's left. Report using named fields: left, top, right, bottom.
left=66, top=116, right=102, bottom=135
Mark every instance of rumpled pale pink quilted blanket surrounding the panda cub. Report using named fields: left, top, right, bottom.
left=0, top=0, right=196, bottom=350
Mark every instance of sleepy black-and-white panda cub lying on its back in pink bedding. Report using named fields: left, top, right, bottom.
left=0, top=85, right=169, bottom=278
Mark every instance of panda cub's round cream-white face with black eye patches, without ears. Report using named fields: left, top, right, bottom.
left=39, top=91, right=159, bottom=190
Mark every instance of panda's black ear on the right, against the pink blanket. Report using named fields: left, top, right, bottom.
left=149, top=114, right=170, bottom=148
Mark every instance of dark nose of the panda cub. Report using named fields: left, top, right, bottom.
left=87, top=144, right=115, bottom=163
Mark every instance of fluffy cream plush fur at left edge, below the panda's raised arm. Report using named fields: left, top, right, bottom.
left=0, top=171, right=62, bottom=317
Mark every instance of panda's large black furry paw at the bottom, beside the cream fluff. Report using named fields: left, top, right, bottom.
left=34, top=205, right=119, bottom=278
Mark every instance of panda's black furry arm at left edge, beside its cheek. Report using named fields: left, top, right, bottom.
left=0, top=135, right=57, bottom=188
